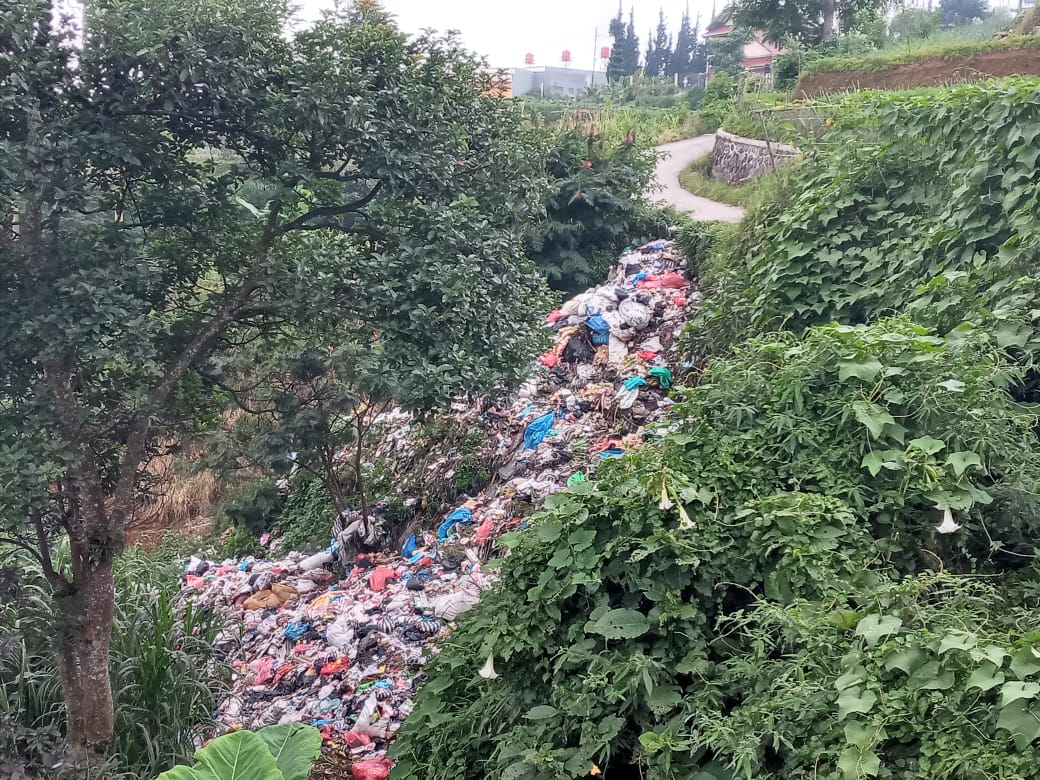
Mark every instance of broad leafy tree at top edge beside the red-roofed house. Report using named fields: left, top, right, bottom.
left=732, top=0, right=883, bottom=47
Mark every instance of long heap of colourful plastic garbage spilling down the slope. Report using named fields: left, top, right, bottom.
left=183, top=241, right=699, bottom=778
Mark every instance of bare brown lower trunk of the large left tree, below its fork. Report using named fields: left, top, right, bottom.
left=56, top=545, right=115, bottom=761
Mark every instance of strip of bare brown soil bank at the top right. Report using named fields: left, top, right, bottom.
left=795, top=49, right=1040, bottom=99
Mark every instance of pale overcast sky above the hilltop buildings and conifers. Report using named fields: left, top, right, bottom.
left=296, top=0, right=722, bottom=68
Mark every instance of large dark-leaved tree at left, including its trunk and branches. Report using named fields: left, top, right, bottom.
left=0, top=0, right=544, bottom=759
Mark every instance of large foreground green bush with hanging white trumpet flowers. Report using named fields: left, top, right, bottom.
left=392, top=320, right=1040, bottom=780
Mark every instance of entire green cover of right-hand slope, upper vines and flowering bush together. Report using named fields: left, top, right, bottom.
left=394, top=80, right=1040, bottom=780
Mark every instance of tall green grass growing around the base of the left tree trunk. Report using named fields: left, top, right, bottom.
left=0, top=550, right=230, bottom=778
